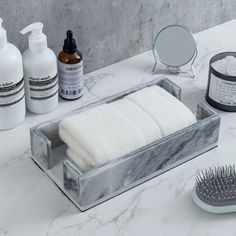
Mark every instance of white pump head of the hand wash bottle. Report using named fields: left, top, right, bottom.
left=20, top=22, right=47, bottom=52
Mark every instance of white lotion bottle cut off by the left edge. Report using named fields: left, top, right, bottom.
left=0, top=18, right=25, bottom=130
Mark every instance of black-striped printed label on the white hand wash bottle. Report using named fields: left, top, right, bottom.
left=29, top=75, right=58, bottom=100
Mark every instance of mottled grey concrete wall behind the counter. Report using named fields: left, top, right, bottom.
left=0, top=0, right=236, bottom=72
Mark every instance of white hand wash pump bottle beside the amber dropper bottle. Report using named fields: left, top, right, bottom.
left=21, top=22, right=58, bottom=114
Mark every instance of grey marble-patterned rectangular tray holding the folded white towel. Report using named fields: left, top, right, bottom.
left=31, top=78, right=220, bottom=211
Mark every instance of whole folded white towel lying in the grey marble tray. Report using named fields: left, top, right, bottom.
left=59, top=86, right=196, bottom=171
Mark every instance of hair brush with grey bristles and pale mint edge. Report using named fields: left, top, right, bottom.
left=192, top=165, right=236, bottom=213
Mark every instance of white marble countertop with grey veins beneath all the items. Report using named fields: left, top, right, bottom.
left=0, top=20, right=236, bottom=236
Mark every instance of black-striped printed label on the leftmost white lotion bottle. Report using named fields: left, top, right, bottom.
left=0, top=79, right=25, bottom=107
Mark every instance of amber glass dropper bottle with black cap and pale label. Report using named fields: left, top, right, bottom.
left=58, top=30, right=83, bottom=100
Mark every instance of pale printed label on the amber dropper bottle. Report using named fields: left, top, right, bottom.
left=58, top=61, right=83, bottom=100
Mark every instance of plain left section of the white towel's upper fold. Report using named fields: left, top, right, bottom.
left=59, top=104, right=146, bottom=167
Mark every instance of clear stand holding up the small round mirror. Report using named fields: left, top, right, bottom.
left=152, top=50, right=198, bottom=78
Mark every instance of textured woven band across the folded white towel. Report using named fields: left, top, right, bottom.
left=110, top=98, right=163, bottom=144
